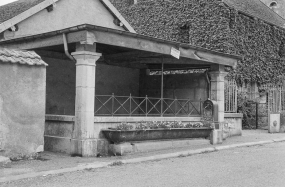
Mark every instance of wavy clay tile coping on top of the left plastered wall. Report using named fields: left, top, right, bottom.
left=0, top=48, right=47, bottom=66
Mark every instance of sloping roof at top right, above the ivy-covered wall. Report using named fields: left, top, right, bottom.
left=223, top=0, right=285, bottom=27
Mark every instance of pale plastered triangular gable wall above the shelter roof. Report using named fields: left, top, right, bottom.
left=4, top=0, right=125, bottom=39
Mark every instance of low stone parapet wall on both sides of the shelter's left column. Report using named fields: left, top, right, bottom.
left=45, top=115, right=201, bottom=155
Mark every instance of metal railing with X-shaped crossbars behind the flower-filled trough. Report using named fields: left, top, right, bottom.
left=95, top=94, right=202, bottom=117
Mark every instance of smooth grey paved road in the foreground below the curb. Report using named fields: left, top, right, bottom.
left=0, top=143, right=285, bottom=187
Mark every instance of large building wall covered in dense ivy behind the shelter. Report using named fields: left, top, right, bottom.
left=111, top=0, right=285, bottom=84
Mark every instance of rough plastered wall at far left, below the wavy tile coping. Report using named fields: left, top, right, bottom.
left=0, top=62, right=46, bottom=157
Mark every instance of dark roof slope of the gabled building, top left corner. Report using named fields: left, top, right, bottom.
left=0, top=0, right=45, bottom=24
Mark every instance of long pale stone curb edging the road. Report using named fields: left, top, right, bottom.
left=0, top=138, right=285, bottom=183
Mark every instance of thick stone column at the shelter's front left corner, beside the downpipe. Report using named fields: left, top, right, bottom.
left=71, top=44, right=101, bottom=157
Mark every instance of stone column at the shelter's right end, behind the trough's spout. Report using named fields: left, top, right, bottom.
left=206, top=65, right=227, bottom=144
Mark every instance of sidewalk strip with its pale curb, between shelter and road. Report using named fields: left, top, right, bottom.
left=0, top=130, right=285, bottom=182
